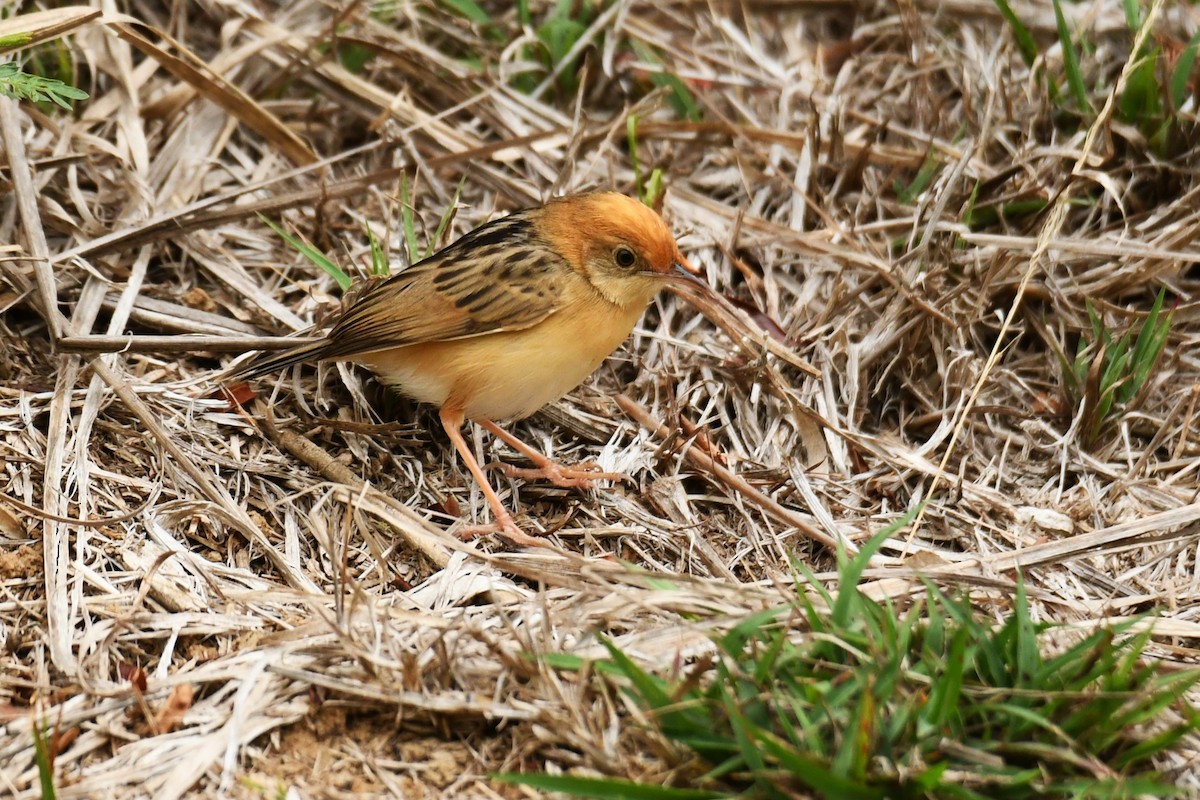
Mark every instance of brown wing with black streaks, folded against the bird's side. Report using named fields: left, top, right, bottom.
left=317, top=213, right=566, bottom=359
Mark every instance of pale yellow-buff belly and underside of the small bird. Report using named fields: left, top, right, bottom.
left=356, top=307, right=642, bottom=420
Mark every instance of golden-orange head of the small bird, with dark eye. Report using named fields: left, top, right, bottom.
left=539, top=192, right=686, bottom=306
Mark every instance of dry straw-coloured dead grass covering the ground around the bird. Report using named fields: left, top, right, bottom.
left=0, top=0, right=1200, bottom=798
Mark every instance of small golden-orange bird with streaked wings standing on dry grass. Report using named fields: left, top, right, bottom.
left=234, top=192, right=707, bottom=545
